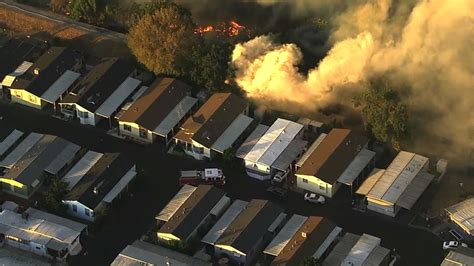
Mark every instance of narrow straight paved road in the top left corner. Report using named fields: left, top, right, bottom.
left=0, top=0, right=126, bottom=41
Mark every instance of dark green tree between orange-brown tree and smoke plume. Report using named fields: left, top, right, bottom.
left=189, top=42, right=232, bottom=92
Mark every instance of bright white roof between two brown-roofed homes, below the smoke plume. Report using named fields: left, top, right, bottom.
left=244, top=118, right=303, bottom=166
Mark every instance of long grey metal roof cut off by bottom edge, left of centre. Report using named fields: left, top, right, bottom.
left=111, top=240, right=211, bottom=266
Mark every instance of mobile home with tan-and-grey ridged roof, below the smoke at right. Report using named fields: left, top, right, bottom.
left=357, top=151, right=433, bottom=217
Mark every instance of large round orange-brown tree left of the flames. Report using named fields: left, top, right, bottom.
left=127, top=1, right=197, bottom=76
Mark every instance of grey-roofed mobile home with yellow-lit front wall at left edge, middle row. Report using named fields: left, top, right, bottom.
left=0, top=133, right=80, bottom=198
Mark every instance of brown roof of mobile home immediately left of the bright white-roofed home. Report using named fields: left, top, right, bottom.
left=175, top=93, right=247, bottom=147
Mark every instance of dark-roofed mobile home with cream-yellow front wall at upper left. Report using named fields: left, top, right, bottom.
left=10, top=47, right=83, bottom=109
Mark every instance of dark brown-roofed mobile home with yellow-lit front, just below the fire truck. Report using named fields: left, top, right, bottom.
left=157, top=185, right=230, bottom=245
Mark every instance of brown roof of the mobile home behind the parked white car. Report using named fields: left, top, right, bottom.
left=296, top=128, right=368, bottom=184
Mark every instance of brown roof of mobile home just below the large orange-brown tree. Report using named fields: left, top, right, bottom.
left=120, top=78, right=191, bottom=130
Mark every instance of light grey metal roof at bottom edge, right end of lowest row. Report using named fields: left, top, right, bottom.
left=342, top=234, right=381, bottom=265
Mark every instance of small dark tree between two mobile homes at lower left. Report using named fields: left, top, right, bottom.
left=42, top=178, right=67, bottom=215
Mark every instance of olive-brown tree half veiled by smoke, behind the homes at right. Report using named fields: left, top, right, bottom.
left=354, top=80, right=408, bottom=147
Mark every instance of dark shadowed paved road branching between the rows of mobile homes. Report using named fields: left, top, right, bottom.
left=0, top=103, right=444, bottom=265
